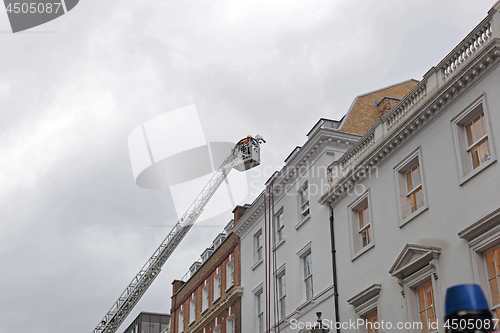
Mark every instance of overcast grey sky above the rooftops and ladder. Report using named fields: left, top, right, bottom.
left=0, top=0, right=495, bottom=333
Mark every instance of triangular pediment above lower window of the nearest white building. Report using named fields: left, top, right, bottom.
left=389, top=244, right=441, bottom=280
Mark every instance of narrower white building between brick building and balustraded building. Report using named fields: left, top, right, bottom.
left=234, top=119, right=360, bottom=333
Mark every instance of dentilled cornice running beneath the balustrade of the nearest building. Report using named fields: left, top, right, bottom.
left=319, top=38, right=500, bottom=207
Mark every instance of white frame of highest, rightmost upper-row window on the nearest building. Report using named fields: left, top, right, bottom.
left=451, top=94, right=497, bottom=185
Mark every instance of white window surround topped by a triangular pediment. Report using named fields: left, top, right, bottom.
left=389, top=244, right=444, bottom=333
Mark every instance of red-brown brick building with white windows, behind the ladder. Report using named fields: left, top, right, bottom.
left=170, top=207, right=244, bottom=333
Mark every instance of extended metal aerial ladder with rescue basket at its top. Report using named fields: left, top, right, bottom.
left=92, top=135, right=266, bottom=333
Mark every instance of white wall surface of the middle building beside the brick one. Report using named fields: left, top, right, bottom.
left=236, top=129, right=359, bottom=333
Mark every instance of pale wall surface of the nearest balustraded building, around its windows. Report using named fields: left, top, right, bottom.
left=334, top=58, right=500, bottom=332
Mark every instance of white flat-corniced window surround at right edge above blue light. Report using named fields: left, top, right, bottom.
left=458, top=208, right=500, bottom=319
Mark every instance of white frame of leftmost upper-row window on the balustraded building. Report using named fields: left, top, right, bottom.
left=347, top=190, right=375, bottom=260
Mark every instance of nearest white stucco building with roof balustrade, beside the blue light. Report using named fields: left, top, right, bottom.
left=320, top=2, right=500, bottom=332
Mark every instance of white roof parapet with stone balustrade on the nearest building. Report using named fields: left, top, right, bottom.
left=320, top=6, right=500, bottom=204
